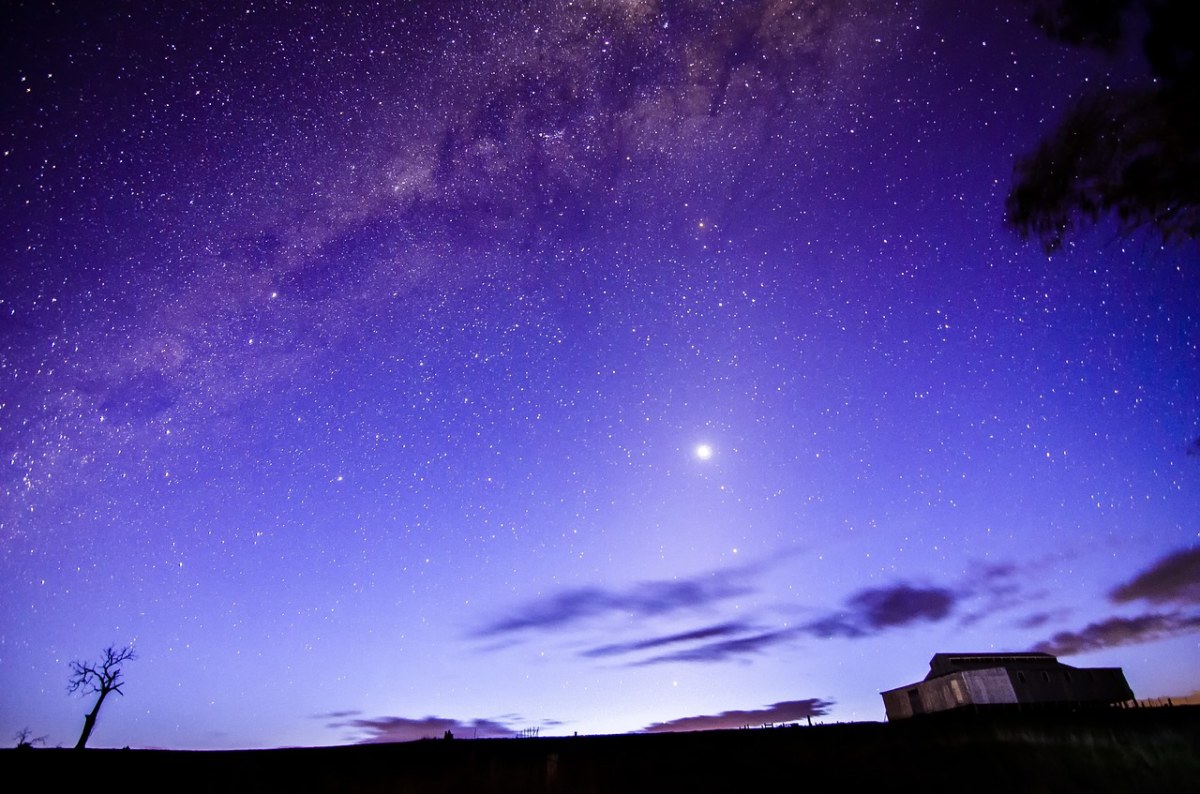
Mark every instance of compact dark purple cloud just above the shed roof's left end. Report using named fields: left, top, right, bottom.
left=804, top=584, right=960, bottom=638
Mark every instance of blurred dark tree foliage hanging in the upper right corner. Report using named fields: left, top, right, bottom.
left=1007, top=0, right=1200, bottom=252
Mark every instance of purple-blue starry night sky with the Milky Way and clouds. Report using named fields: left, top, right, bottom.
left=0, top=0, right=1200, bottom=748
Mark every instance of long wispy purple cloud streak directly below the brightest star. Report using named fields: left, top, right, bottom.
left=475, top=570, right=752, bottom=637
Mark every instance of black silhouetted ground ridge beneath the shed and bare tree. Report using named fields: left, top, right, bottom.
left=7, top=706, right=1200, bottom=794
